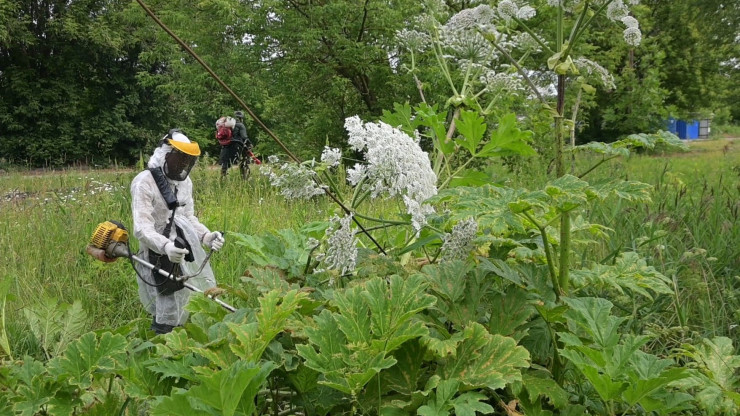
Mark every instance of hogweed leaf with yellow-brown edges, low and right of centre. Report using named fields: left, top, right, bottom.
left=437, top=323, right=529, bottom=389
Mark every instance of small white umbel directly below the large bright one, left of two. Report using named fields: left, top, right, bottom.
left=317, top=214, right=357, bottom=274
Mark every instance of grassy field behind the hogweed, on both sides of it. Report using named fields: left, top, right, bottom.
left=0, top=139, right=740, bottom=358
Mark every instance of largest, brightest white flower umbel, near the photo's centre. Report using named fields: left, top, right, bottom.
left=344, top=116, right=437, bottom=232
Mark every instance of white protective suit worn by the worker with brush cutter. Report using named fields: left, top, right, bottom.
left=131, top=135, right=223, bottom=329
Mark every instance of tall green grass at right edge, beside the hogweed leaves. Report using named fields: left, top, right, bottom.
left=592, top=140, right=740, bottom=344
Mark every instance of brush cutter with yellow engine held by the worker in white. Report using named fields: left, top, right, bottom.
left=86, top=221, right=236, bottom=312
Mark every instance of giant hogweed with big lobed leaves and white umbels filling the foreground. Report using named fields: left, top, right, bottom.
left=0, top=0, right=740, bottom=416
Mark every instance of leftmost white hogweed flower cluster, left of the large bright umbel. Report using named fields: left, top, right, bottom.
left=260, top=156, right=324, bottom=199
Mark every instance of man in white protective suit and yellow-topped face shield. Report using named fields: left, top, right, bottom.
left=131, top=129, right=224, bottom=334
